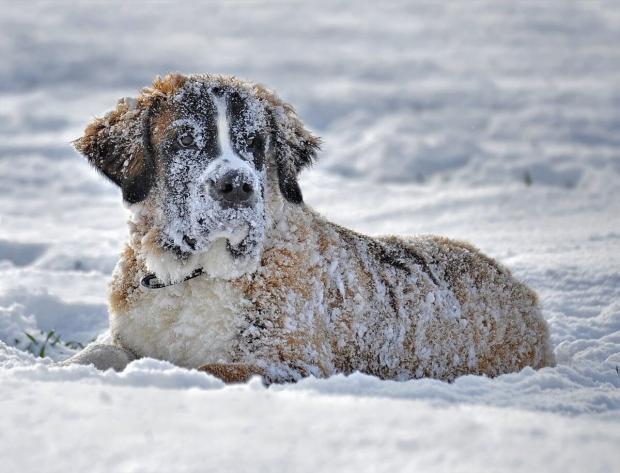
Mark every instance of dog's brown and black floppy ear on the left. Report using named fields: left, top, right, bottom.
left=73, top=99, right=155, bottom=204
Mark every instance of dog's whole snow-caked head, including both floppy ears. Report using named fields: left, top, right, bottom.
left=75, top=74, right=319, bottom=281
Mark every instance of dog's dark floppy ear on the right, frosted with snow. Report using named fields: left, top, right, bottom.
left=258, top=86, right=321, bottom=204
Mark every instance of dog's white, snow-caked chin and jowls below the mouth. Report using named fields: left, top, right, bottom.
left=145, top=236, right=260, bottom=284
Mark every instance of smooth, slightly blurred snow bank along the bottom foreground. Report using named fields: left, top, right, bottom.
left=0, top=364, right=619, bottom=472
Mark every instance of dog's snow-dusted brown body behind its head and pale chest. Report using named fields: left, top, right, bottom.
left=230, top=209, right=553, bottom=380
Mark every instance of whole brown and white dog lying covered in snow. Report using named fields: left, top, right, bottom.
left=70, top=74, right=554, bottom=383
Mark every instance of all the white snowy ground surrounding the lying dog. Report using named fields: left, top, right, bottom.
left=0, top=0, right=620, bottom=472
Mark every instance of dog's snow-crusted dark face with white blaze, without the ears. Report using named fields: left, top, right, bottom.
left=145, top=82, right=269, bottom=267
